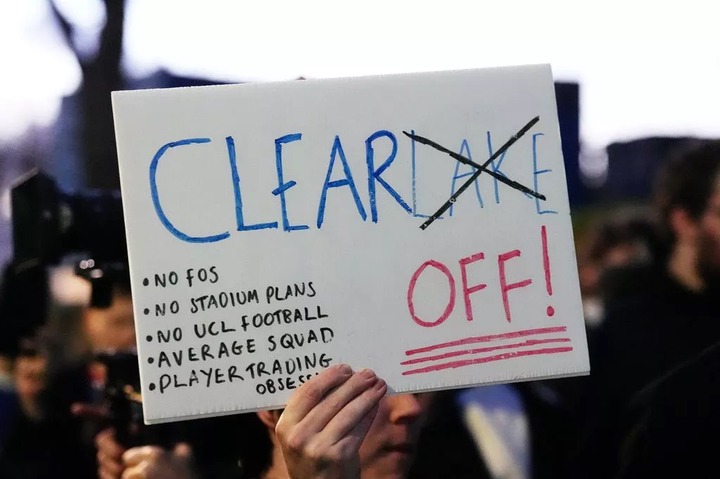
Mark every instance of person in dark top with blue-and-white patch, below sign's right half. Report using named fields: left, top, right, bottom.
left=409, top=379, right=577, bottom=479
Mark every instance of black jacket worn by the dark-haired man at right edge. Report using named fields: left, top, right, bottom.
left=571, top=270, right=720, bottom=479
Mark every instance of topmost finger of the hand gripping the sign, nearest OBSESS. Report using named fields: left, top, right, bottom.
left=278, top=364, right=352, bottom=424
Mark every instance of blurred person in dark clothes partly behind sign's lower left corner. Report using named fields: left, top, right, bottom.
left=46, top=263, right=253, bottom=479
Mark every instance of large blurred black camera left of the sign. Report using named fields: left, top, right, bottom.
left=0, top=169, right=127, bottom=354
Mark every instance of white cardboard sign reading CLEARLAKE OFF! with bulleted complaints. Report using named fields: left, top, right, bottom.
left=113, top=65, right=589, bottom=423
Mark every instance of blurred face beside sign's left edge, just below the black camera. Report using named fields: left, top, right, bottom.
left=84, top=292, right=135, bottom=352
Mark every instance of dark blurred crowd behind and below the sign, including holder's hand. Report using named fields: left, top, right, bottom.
left=0, top=141, right=720, bottom=479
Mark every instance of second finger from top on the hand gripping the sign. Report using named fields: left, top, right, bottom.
left=299, top=369, right=378, bottom=433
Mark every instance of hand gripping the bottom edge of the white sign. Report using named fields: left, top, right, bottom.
left=275, top=365, right=387, bottom=479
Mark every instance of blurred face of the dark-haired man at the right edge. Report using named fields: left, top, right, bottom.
left=697, top=190, right=720, bottom=289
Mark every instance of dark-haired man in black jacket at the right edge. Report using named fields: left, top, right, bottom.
left=574, top=141, right=720, bottom=478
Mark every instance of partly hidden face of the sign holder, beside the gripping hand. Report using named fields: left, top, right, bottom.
left=360, top=393, right=433, bottom=479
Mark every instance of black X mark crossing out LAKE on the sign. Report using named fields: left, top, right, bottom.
left=403, top=116, right=545, bottom=230
